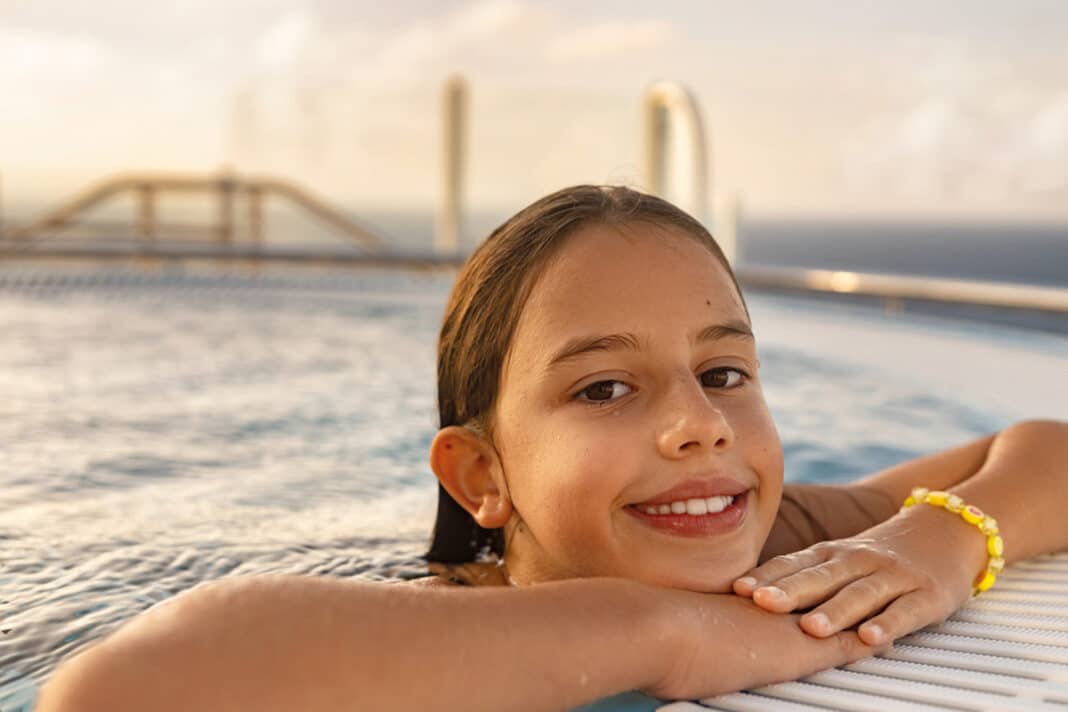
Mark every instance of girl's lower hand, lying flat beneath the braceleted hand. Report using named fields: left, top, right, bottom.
left=643, top=589, right=888, bottom=699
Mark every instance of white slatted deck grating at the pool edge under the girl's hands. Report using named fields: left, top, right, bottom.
left=658, top=552, right=1068, bottom=712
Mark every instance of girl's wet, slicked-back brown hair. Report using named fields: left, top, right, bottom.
left=426, top=186, right=744, bottom=564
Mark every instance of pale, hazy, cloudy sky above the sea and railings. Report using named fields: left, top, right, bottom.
left=0, top=0, right=1068, bottom=221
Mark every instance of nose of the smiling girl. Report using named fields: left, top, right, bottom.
left=657, top=376, right=735, bottom=459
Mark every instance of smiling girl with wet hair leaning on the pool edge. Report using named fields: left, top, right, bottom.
left=38, top=186, right=1068, bottom=712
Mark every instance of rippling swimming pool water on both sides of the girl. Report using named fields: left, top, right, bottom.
left=0, top=266, right=1068, bottom=712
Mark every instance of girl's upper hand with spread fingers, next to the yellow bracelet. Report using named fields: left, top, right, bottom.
left=734, top=506, right=986, bottom=645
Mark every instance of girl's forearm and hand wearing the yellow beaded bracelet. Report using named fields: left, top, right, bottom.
left=735, top=421, right=1068, bottom=644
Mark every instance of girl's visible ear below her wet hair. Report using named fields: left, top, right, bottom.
left=430, top=425, right=512, bottom=529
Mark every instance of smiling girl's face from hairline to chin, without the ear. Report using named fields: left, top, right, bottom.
left=493, top=224, right=783, bottom=591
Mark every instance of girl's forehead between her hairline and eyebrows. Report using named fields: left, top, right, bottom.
left=512, top=223, right=749, bottom=358
